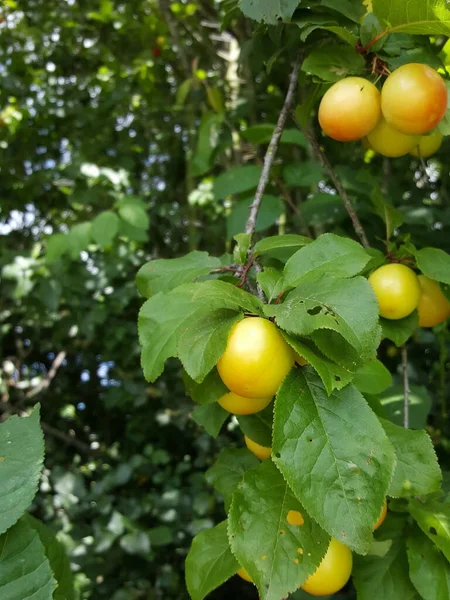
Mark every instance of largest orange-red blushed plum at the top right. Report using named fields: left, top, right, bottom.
left=381, top=63, right=447, bottom=134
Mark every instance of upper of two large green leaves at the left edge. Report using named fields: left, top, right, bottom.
left=0, top=405, right=44, bottom=536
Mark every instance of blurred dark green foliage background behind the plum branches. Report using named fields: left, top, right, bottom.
left=0, top=0, right=450, bottom=600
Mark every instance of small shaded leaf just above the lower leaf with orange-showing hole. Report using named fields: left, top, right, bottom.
left=205, top=448, right=259, bottom=510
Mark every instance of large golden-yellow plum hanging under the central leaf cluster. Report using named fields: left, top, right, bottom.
left=217, top=317, right=294, bottom=398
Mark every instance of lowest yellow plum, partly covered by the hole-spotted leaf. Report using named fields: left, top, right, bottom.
left=300, top=538, right=353, bottom=596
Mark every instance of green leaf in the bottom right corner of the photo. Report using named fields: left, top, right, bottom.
left=406, top=528, right=450, bottom=600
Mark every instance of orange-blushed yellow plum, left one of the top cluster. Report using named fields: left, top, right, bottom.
left=319, top=77, right=381, bottom=142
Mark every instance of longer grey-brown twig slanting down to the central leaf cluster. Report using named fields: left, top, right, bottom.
left=245, top=57, right=300, bottom=235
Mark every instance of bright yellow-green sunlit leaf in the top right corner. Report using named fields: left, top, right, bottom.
left=372, top=0, right=450, bottom=35
